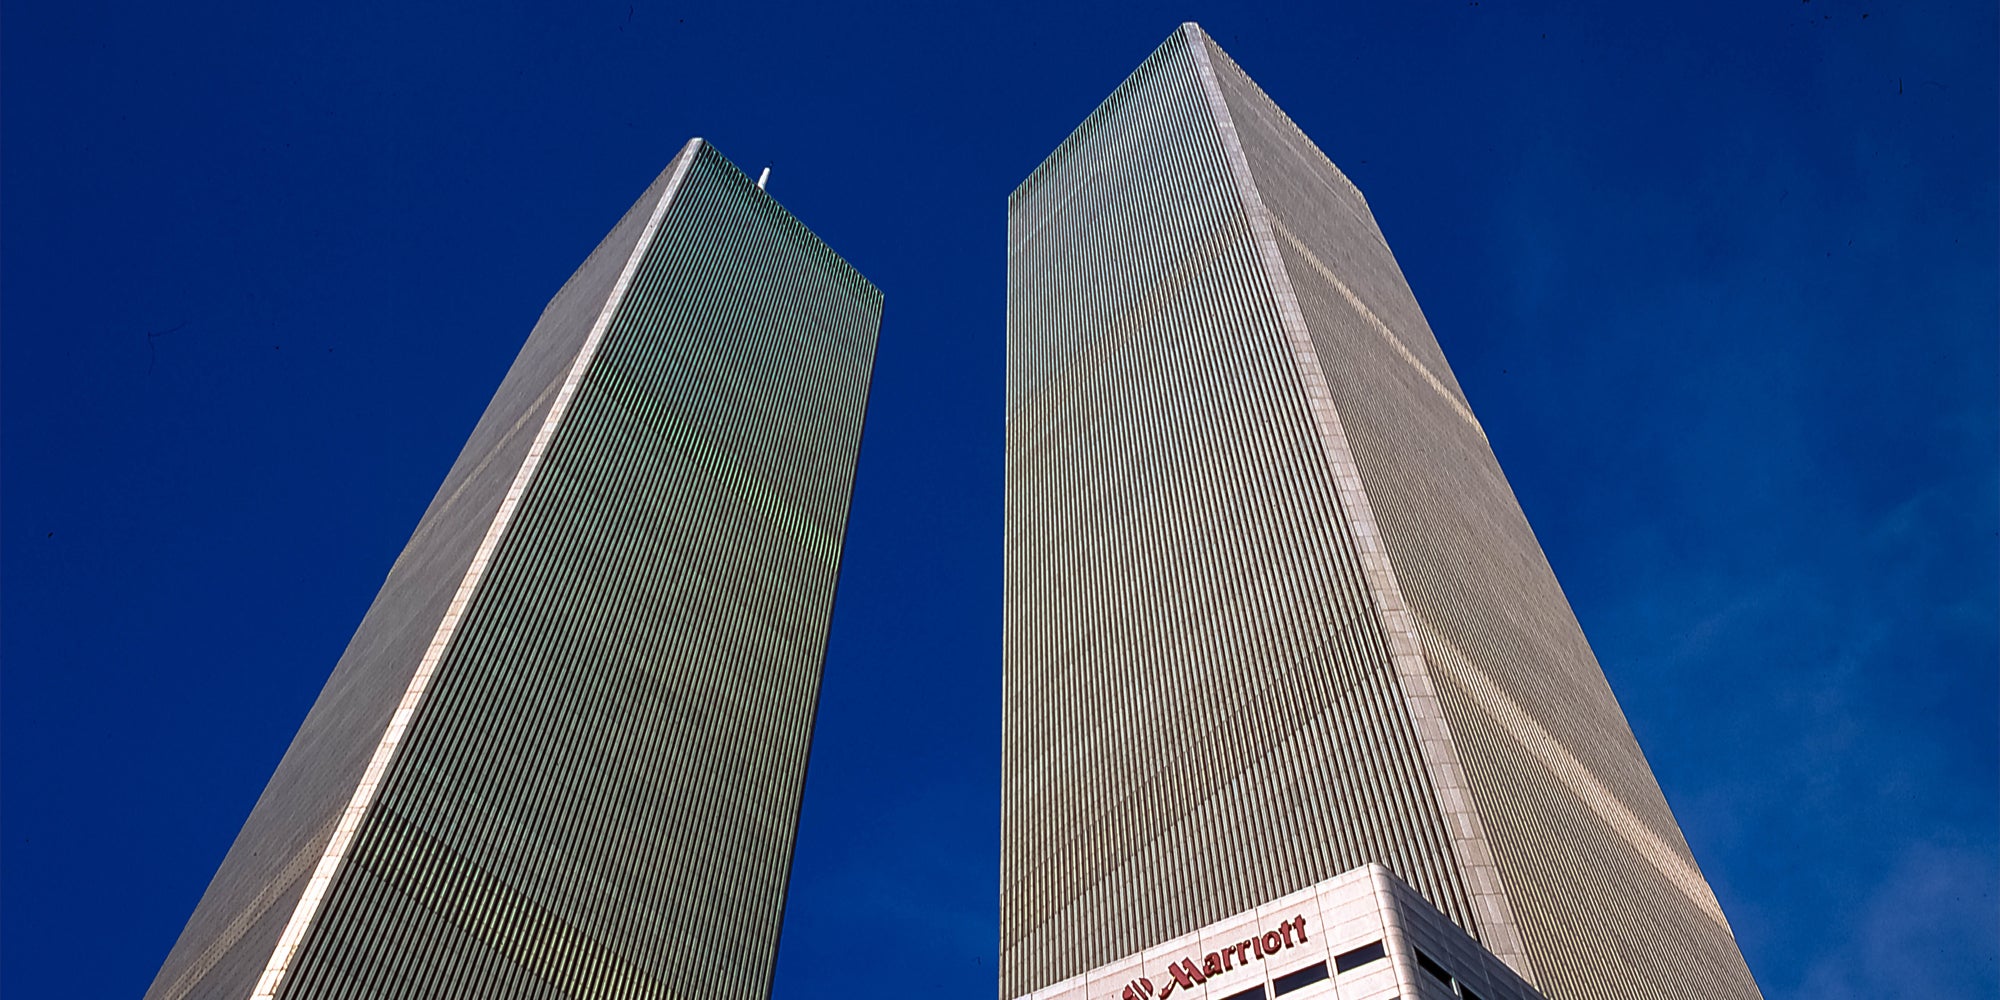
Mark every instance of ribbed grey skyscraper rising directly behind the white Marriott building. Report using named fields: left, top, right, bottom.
left=1000, top=24, right=1758, bottom=1000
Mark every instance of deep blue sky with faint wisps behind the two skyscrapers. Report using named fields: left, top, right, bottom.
left=0, top=0, right=2000, bottom=1000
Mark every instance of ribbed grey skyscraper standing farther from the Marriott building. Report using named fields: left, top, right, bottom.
left=146, top=140, right=882, bottom=1000
